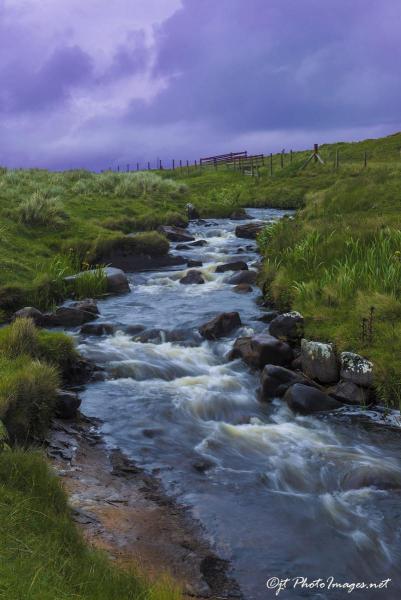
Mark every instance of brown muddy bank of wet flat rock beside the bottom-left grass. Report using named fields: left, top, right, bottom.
left=47, top=416, right=242, bottom=599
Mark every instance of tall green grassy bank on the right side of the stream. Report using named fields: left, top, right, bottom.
left=259, top=135, right=401, bottom=407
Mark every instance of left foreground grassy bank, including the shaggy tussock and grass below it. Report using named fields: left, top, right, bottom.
left=0, top=319, right=179, bottom=600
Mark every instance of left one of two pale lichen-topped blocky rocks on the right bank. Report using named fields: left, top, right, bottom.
left=301, top=339, right=339, bottom=383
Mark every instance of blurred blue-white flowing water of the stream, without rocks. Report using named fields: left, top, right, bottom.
left=73, top=210, right=401, bottom=600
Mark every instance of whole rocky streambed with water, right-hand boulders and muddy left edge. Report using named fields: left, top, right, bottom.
left=42, top=210, right=401, bottom=600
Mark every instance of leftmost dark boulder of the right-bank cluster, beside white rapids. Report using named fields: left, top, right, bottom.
left=229, top=333, right=293, bottom=369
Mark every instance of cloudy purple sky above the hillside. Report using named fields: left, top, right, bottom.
left=0, top=0, right=401, bottom=169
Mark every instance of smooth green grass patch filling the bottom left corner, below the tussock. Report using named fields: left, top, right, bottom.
left=0, top=450, right=180, bottom=600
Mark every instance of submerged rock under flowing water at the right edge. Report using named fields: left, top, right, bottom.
left=341, top=465, right=401, bottom=490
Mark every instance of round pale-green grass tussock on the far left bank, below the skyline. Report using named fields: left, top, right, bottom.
left=18, top=191, right=67, bottom=227
